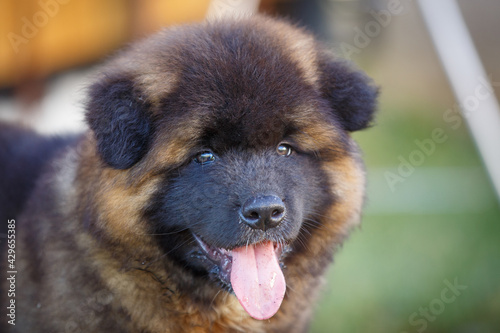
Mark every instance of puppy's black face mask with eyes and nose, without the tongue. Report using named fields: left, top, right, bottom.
left=151, top=128, right=334, bottom=287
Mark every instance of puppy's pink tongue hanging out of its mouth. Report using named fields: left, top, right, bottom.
left=231, top=242, right=286, bottom=320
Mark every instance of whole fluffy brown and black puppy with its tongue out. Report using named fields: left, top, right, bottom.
left=2, top=17, right=377, bottom=333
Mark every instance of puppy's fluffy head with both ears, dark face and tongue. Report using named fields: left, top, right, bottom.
left=87, top=18, right=376, bottom=319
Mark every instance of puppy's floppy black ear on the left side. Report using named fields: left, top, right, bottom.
left=86, top=78, right=152, bottom=169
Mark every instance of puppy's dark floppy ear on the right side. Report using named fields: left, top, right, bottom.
left=319, top=56, right=378, bottom=132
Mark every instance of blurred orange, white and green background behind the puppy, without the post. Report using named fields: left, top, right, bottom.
left=0, top=0, right=500, bottom=333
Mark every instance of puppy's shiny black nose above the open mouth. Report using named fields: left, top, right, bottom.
left=240, top=195, right=286, bottom=231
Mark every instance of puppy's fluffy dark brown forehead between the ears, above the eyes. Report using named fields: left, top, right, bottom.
left=162, top=18, right=318, bottom=147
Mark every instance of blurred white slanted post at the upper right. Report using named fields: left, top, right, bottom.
left=418, top=0, right=500, bottom=199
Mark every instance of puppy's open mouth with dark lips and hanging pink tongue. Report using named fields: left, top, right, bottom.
left=193, top=234, right=290, bottom=320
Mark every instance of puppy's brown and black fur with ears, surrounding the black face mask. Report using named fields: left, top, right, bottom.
left=2, top=17, right=376, bottom=333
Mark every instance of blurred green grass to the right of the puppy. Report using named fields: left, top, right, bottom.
left=311, top=105, right=500, bottom=333
